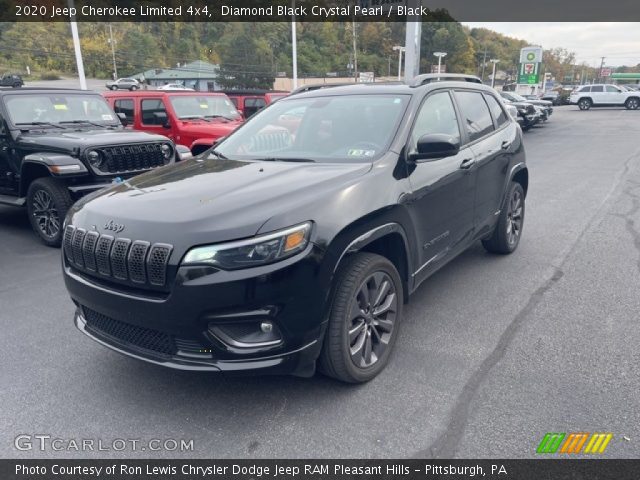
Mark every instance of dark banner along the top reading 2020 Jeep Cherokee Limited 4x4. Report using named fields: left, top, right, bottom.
left=0, top=0, right=640, bottom=22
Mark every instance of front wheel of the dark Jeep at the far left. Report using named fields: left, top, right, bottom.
left=27, top=177, right=73, bottom=247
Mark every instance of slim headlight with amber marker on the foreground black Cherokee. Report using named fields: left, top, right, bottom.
left=182, top=222, right=311, bottom=270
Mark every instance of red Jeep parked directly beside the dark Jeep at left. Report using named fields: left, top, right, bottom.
left=103, top=90, right=243, bottom=155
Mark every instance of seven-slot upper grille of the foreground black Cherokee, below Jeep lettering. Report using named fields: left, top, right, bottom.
left=63, top=225, right=173, bottom=287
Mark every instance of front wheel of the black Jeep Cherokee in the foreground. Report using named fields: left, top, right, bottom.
left=319, top=253, right=404, bottom=383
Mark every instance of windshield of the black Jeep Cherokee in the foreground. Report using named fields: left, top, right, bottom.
left=215, top=95, right=410, bottom=162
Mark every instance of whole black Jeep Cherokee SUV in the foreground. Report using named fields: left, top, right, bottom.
left=63, top=75, right=529, bottom=382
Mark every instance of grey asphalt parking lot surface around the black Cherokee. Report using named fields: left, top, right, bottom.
left=0, top=107, right=640, bottom=458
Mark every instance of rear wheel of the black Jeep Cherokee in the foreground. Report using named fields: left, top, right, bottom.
left=482, top=182, right=525, bottom=255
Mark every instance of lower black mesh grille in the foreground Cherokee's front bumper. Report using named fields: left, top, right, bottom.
left=82, top=307, right=178, bottom=356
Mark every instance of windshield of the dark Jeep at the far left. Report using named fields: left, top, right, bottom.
left=5, top=93, right=120, bottom=126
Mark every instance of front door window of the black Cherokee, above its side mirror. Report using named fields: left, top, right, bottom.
left=411, top=92, right=460, bottom=146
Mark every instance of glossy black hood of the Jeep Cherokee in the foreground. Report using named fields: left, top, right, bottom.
left=67, top=158, right=371, bottom=251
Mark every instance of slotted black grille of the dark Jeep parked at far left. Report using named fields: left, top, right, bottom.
left=95, top=143, right=165, bottom=174
